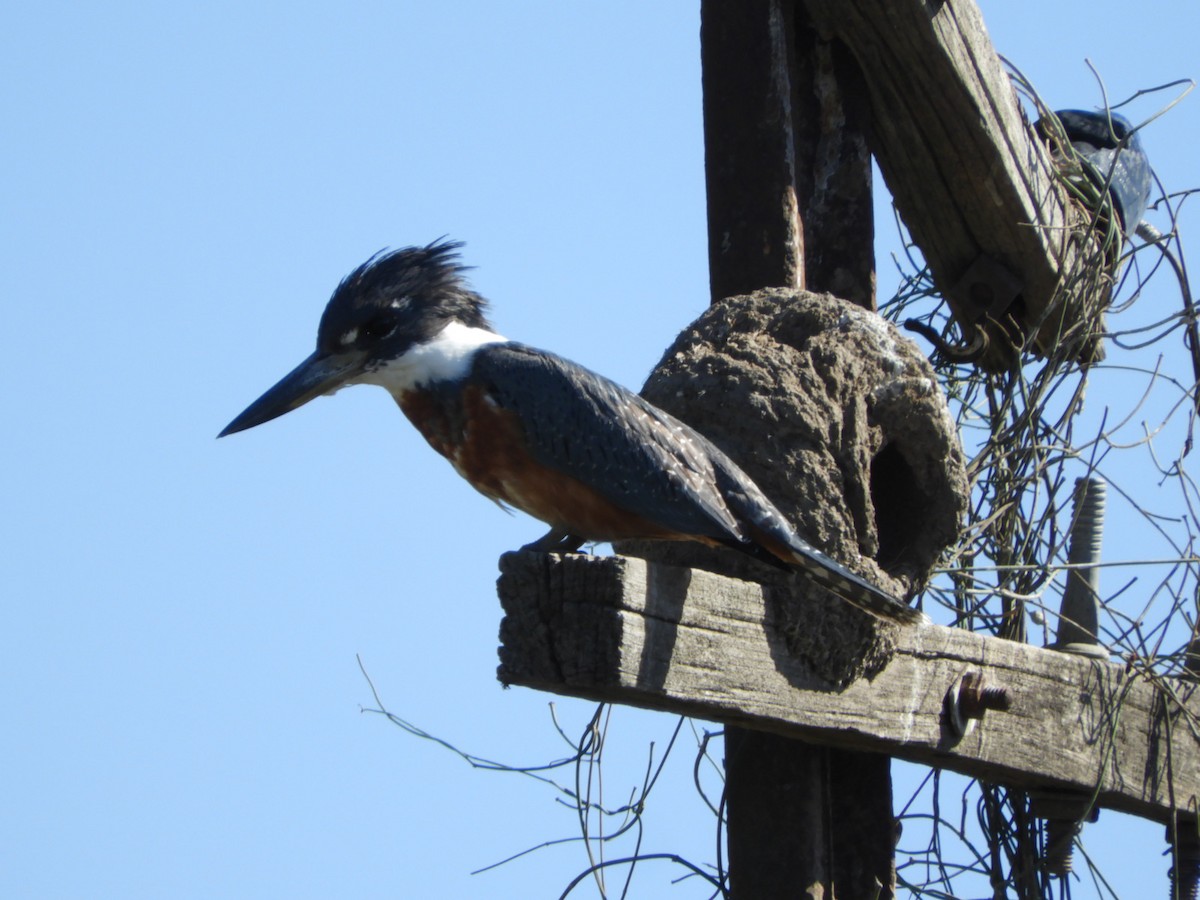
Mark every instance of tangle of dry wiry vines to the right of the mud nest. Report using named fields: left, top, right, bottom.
left=881, top=73, right=1200, bottom=900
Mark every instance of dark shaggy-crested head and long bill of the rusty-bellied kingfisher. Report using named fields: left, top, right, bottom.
left=218, top=240, right=500, bottom=437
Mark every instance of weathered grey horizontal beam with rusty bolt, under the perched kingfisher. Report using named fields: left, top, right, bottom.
left=499, top=553, right=1200, bottom=822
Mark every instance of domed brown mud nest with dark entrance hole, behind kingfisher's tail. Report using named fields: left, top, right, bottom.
left=622, top=289, right=968, bottom=614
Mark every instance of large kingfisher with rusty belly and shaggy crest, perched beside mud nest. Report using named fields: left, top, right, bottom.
left=218, top=238, right=924, bottom=624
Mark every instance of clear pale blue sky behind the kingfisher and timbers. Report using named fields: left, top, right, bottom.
left=0, top=0, right=1200, bottom=898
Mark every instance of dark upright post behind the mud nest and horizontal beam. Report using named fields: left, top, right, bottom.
left=701, top=0, right=895, bottom=899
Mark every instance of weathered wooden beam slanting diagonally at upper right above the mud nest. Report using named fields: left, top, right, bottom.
left=803, top=0, right=1096, bottom=364
